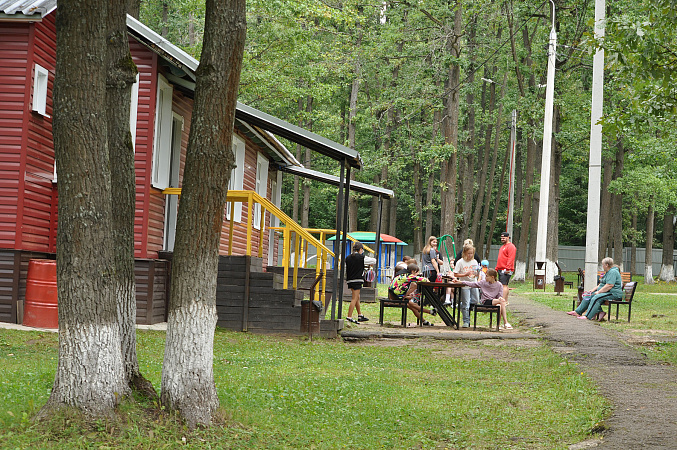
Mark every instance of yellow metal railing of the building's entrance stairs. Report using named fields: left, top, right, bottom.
left=162, top=188, right=334, bottom=303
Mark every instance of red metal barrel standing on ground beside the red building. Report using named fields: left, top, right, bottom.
left=23, top=259, right=59, bottom=328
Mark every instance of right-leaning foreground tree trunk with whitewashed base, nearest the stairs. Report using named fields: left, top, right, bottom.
left=161, top=0, right=246, bottom=428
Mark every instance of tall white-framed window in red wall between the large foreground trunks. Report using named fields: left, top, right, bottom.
left=151, top=75, right=174, bottom=189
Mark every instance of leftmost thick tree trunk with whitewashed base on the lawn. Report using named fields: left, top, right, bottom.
left=40, top=0, right=129, bottom=417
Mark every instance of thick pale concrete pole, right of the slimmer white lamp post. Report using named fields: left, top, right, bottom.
left=584, top=0, right=606, bottom=291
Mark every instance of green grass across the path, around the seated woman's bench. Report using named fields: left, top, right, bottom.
left=508, top=273, right=677, bottom=365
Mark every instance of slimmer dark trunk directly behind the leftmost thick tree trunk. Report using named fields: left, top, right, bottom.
left=106, top=0, right=157, bottom=398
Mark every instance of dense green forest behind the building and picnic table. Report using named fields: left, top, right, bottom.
left=141, top=0, right=677, bottom=280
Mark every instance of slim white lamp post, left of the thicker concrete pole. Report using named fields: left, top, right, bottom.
left=534, top=0, right=557, bottom=282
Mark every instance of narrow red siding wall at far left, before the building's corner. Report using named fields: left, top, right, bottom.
left=0, top=23, right=30, bottom=249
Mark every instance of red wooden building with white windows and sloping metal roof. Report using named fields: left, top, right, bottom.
left=0, top=0, right=380, bottom=334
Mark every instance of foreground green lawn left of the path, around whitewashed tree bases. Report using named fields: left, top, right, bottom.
left=0, top=329, right=608, bottom=449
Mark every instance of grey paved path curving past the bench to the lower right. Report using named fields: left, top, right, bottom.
left=509, top=295, right=677, bottom=449
